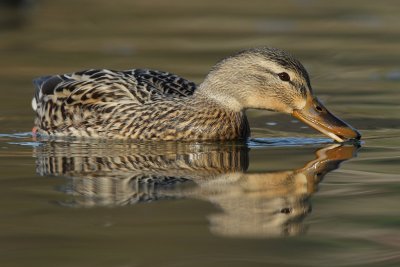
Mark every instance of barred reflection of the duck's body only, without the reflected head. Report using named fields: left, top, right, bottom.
left=34, top=141, right=249, bottom=206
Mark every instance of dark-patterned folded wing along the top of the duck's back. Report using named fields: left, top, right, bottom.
left=32, top=69, right=196, bottom=110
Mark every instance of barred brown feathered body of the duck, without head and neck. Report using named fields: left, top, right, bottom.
left=32, top=69, right=250, bottom=140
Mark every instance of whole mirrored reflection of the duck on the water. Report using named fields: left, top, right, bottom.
left=36, top=142, right=356, bottom=239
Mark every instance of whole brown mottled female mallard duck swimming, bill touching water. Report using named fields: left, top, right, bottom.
left=32, top=48, right=361, bottom=142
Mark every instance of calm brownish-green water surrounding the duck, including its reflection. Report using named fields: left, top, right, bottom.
left=0, top=0, right=400, bottom=267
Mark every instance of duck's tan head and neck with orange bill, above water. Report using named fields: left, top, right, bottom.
left=198, top=48, right=361, bottom=142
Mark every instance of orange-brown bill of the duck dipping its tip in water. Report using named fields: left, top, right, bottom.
left=292, top=97, right=361, bottom=142
